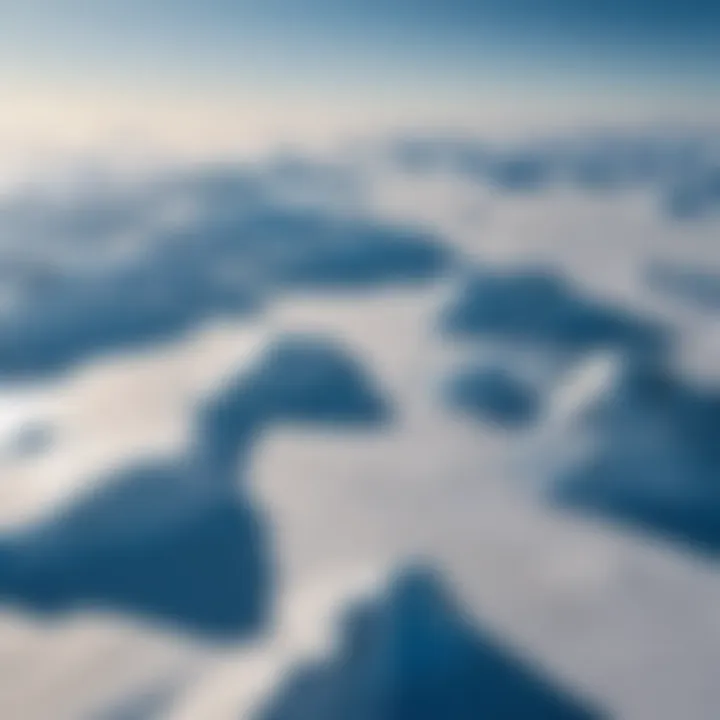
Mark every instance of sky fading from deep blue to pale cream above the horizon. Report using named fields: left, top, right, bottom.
left=0, top=0, right=720, bottom=153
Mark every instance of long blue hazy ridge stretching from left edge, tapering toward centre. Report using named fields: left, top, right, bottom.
left=0, top=167, right=449, bottom=380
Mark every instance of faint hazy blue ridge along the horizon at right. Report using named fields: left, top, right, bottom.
left=389, top=131, right=720, bottom=220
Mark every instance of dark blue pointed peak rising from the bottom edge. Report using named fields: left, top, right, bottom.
left=257, top=567, right=601, bottom=720
